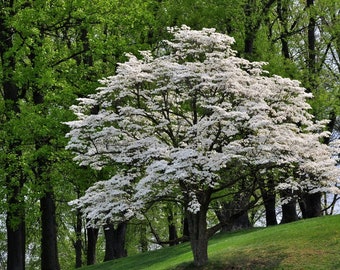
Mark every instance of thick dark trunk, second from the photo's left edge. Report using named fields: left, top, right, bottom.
left=40, top=191, right=60, bottom=270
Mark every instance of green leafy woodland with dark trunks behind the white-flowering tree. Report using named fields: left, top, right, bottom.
left=0, top=0, right=340, bottom=269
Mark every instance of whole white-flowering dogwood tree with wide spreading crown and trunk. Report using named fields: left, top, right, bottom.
left=67, top=26, right=337, bottom=266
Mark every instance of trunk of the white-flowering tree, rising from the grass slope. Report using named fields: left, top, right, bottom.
left=186, top=193, right=210, bottom=267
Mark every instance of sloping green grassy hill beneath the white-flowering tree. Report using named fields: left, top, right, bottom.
left=83, top=215, right=340, bottom=270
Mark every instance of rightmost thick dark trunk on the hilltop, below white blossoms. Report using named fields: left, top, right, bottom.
left=299, top=192, right=322, bottom=218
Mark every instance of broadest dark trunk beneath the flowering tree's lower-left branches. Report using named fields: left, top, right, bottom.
left=104, top=222, right=127, bottom=261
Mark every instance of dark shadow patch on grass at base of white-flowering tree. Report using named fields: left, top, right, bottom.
left=171, top=250, right=285, bottom=270
